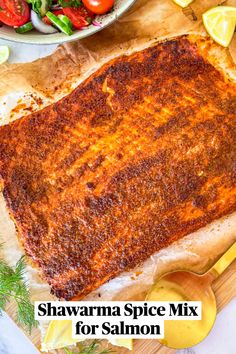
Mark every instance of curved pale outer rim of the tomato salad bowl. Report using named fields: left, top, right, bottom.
left=0, top=0, right=136, bottom=45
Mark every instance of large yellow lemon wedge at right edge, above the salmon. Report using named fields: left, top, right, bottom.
left=202, top=6, right=236, bottom=47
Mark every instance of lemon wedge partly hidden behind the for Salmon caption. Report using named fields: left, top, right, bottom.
left=41, top=320, right=133, bottom=351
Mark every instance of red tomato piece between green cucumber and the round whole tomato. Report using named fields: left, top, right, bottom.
left=63, top=7, right=94, bottom=29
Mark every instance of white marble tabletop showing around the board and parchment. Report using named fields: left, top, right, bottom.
left=0, top=39, right=236, bottom=354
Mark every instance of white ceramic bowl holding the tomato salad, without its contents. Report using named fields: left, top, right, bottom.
left=0, top=0, right=136, bottom=44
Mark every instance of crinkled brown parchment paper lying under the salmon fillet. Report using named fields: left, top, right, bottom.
left=0, top=0, right=236, bottom=354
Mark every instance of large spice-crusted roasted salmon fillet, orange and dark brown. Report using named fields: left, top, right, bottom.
left=0, top=36, right=236, bottom=299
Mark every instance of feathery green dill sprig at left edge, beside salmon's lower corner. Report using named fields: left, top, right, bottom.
left=0, top=245, right=38, bottom=332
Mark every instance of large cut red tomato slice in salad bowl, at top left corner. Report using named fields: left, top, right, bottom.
left=0, top=0, right=30, bottom=27
